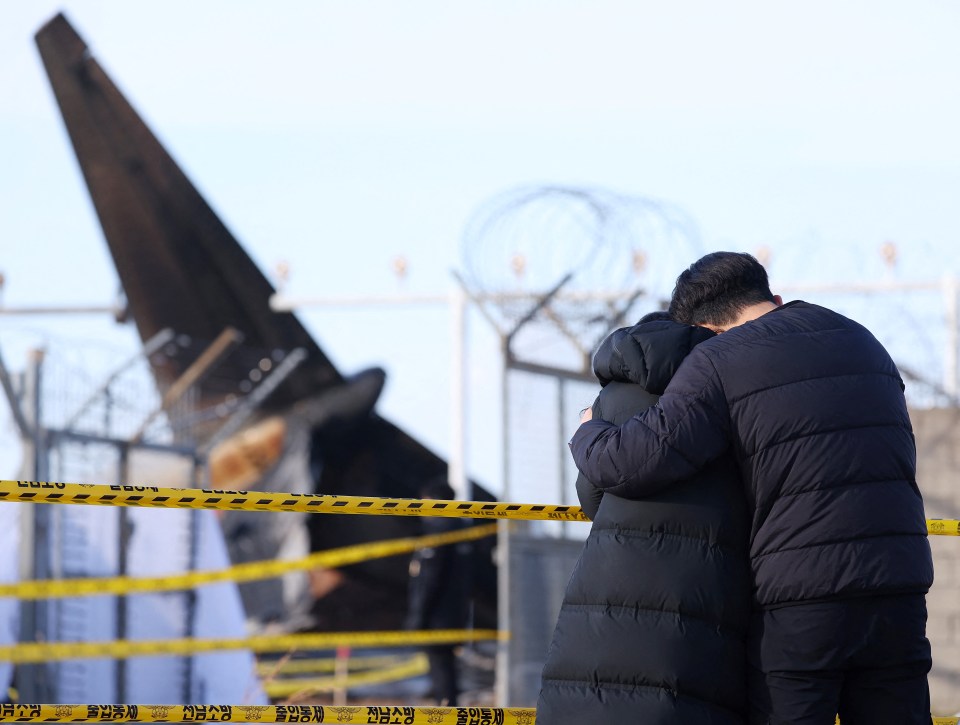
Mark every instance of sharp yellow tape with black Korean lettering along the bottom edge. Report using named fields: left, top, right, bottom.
left=0, top=705, right=536, bottom=725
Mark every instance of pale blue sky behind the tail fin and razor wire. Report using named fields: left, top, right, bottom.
left=0, top=0, right=960, bottom=498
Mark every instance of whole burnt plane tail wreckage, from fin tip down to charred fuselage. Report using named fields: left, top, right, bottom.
left=36, top=15, right=496, bottom=631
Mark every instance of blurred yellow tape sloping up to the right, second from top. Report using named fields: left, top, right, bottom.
left=0, top=524, right=497, bottom=599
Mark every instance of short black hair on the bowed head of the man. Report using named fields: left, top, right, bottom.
left=670, top=252, right=775, bottom=325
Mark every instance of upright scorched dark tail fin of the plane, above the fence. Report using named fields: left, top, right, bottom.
left=36, top=14, right=342, bottom=407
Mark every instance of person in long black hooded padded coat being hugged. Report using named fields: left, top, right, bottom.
left=537, top=313, right=750, bottom=725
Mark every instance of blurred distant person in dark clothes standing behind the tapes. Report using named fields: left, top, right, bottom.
left=406, top=479, right=470, bottom=707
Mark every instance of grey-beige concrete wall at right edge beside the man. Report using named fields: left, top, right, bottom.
left=910, top=408, right=960, bottom=715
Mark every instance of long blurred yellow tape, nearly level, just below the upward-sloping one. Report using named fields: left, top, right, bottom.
left=0, top=629, right=509, bottom=663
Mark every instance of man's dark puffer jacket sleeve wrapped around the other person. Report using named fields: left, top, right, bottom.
left=570, top=343, right=730, bottom=499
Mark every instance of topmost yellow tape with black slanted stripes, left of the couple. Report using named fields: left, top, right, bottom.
left=0, top=480, right=589, bottom=521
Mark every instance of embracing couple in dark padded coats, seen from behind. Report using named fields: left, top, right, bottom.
left=537, top=252, right=933, bottom=725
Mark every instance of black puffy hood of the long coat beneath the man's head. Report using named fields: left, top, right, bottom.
left=593, top=320, right=716, bottom=395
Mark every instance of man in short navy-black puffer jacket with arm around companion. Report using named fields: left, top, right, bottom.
left=570, top=252, right=933, bottom=725
